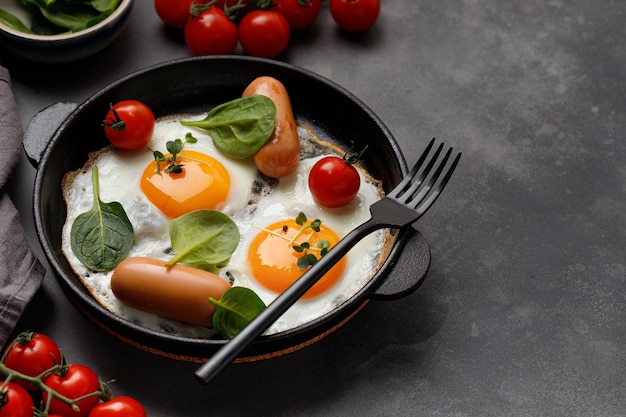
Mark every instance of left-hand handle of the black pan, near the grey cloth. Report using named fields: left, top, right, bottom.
left=23, top=101, right=78, bottom=168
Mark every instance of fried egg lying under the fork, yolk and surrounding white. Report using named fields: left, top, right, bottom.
left=221, top=155, right=384, bottom=334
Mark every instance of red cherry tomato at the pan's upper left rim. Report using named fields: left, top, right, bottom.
left=103, top=100, right=154, bottom=150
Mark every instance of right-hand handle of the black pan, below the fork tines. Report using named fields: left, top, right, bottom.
left=370, top=228, right=430, bottom=300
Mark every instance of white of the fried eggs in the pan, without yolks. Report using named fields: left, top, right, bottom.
left=62, top=116, right=384, bottom=338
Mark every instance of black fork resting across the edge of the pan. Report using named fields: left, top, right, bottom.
left=195, top=139, right=461, bottom=384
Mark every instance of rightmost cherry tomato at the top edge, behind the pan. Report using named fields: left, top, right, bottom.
left=329, top=0, right=380, bottom=32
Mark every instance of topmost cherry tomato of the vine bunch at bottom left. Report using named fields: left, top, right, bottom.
left=4, top=332, right=61, bottom=390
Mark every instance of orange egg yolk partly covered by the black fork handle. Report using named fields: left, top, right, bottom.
left=248, top=220, right=346, bottom=298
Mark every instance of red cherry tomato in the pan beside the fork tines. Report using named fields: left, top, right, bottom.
left=309, top=156, right=361, bottom=208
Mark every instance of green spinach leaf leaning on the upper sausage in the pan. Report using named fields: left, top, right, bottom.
left=181, top=94, right=276, bottom=159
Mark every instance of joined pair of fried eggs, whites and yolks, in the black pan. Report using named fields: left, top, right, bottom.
left=62, top=115, right=386, bottom=338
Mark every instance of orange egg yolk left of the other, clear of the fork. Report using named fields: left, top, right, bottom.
left=140, top=150, right=230, bottom=218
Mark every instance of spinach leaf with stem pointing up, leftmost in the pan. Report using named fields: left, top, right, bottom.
left=70, top=166, right=135, bottom=271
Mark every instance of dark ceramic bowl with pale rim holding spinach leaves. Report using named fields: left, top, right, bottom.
left=0, top=0, right=134, bottom=63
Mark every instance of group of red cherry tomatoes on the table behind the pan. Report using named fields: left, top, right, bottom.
left=154, top=0, right=380, bottom=58
